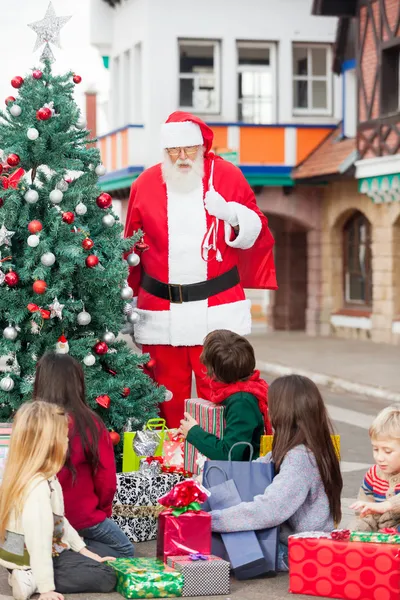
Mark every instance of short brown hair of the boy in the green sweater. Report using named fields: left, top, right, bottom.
left=200, top=329, right=256, bottom=383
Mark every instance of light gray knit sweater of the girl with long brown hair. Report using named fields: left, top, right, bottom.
left=211, top=445, right=333, bottom=544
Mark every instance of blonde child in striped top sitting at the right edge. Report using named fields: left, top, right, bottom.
left=350, top=405, right=400, bottom=531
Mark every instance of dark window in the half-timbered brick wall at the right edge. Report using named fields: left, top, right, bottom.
left=381, top=46, right=400, bottom=115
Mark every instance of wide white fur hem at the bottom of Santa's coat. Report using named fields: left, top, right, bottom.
left=135, top=300, right=251, bottom=346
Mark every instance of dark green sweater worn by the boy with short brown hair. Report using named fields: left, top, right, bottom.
left=187, top=392, right=264, bottom=460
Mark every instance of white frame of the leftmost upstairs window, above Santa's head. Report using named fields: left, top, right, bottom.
left=178, top=38, right=221, bottom=115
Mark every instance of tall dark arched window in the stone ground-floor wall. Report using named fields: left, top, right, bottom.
left=343, top=211, right=372, bottom=306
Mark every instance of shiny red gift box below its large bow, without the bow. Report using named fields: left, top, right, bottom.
left=157, top=510, right=211, bottom=562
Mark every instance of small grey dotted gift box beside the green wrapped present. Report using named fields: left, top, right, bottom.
left=167, top=554, right=230, bottom=596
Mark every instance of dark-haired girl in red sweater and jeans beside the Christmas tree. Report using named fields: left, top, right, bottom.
left=34, top=352, right=134, bottom=557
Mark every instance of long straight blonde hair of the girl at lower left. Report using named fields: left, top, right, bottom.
left=0, top=400, right=68, bottom=540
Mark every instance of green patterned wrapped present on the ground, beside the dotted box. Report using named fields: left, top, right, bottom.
left=108, top=558, right=183, bottom=598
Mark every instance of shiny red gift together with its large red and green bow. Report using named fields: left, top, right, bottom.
left=157, top=479, right=211, bottom=561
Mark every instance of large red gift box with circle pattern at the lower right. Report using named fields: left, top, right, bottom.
left=289, top=537, right=400, bottom=600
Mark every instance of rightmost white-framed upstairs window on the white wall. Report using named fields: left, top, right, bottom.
left=293, top=44, right=332, bottom=115
